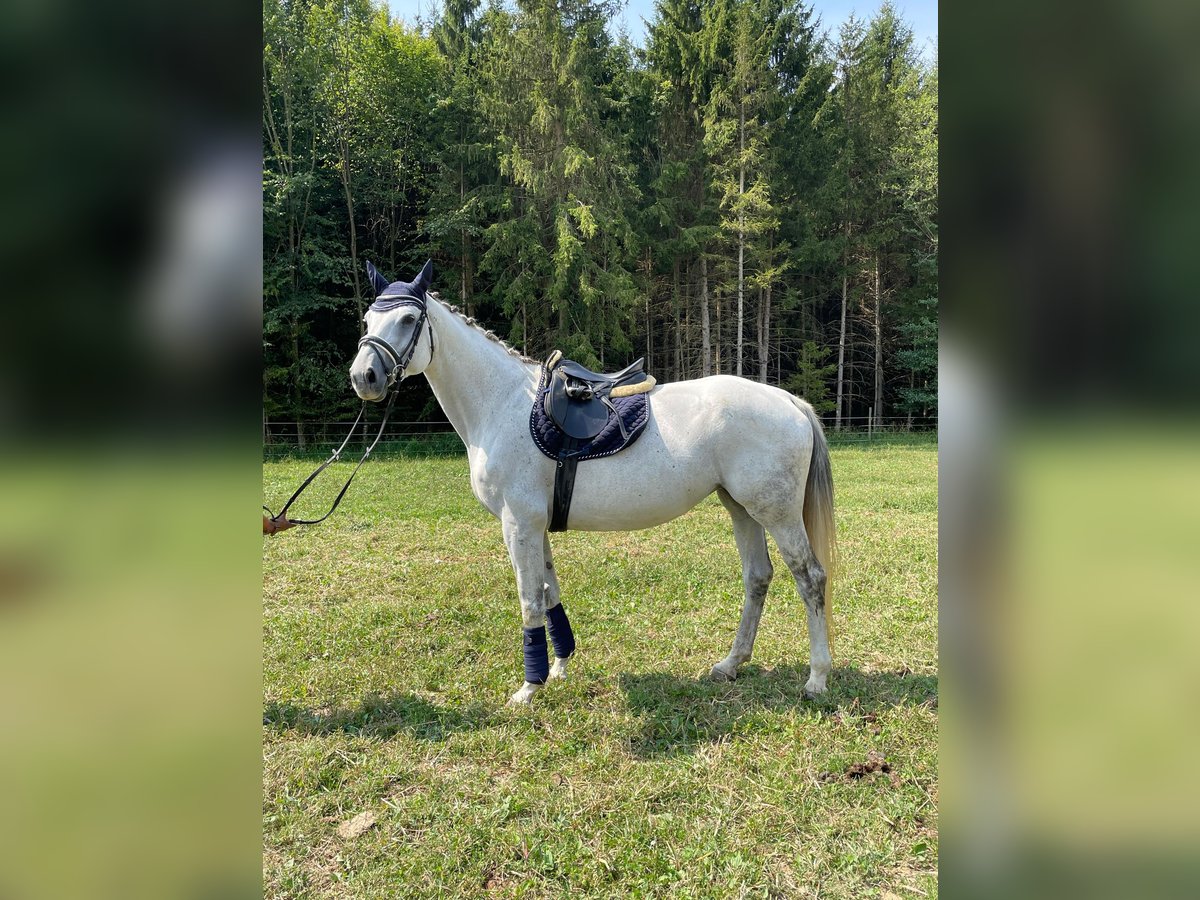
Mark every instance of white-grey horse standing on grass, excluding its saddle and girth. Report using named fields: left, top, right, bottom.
left=350, top=264, right=836, bottom=703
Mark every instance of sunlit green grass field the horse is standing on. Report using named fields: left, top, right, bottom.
left=263, top=439, right=937, bottom=898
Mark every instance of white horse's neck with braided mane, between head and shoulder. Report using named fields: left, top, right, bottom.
left=425, top=300, right=536, bottom=446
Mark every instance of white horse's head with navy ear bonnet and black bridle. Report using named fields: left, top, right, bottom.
left=350, top=259, right=433, bottom=400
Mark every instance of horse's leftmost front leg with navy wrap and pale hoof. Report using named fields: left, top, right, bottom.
left=500, top=508, right=550, bottom=706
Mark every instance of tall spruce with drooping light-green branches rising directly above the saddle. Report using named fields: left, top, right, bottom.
left=482, top=0, right=640, bottom=365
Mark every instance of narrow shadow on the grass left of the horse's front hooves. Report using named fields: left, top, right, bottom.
left=263, top=694, right=492, bottom=742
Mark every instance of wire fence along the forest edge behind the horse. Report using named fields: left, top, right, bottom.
left=263, top=415, right=937, bottom=460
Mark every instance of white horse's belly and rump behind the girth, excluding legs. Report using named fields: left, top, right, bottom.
left=568, top=376, right=812, bottom=532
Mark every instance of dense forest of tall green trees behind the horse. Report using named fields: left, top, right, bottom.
left=263, top=0, right=937, bottom=444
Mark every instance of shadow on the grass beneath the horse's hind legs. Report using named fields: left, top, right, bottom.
left=620, top=665, right=937, bottom=758
